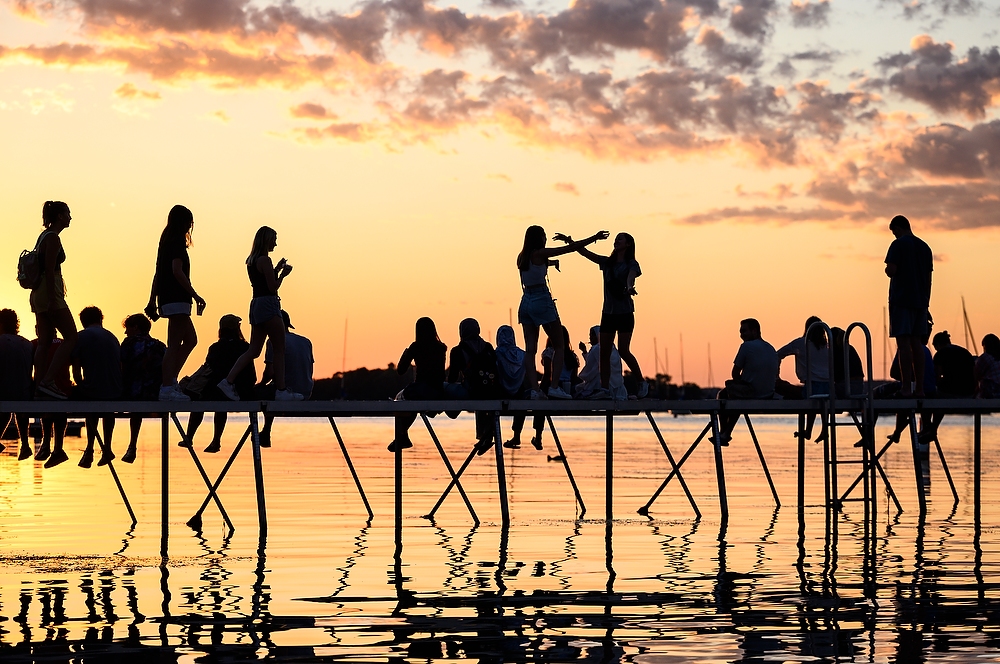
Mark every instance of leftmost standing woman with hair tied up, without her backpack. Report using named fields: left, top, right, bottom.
left=29, top=201, right=76, bottom=399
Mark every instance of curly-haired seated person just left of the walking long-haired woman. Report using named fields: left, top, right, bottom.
left=121, top=314, right=167, bottom=463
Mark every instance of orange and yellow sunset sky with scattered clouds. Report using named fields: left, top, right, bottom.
left=0, top=0, right=1000, bottom=384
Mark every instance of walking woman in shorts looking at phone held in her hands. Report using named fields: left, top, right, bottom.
left=218, top=226, right=302, bottom=401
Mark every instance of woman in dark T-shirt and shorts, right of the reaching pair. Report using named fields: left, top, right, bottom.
left=556, top=233, right=649, bottom=399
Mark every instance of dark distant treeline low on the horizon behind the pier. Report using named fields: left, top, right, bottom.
left=312, top=362, right=718, bottom=401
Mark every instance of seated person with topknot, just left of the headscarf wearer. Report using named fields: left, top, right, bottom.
left=445, top=318, right=499, bottom=454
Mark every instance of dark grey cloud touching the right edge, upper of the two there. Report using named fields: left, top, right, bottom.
left=877, top=35, right=1000, bottom=118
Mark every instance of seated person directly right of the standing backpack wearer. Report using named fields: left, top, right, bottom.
left=73, top=307, right=122, bottom=468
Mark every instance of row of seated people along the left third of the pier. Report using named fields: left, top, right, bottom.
left=0, top=306, right=313, bottom=468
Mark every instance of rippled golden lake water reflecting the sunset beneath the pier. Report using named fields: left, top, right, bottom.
left=0, top=416, right=1000, bottom=663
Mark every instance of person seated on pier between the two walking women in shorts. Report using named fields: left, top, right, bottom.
left=177, top=314, right=257, bottom=454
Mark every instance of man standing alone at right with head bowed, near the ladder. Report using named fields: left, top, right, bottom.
left=885, top=215, right=934, bottom=398
